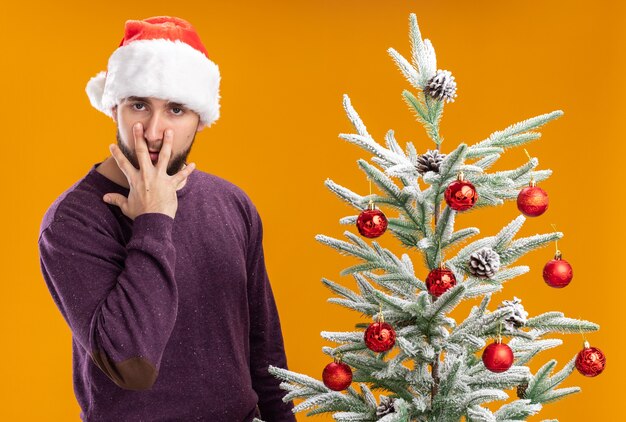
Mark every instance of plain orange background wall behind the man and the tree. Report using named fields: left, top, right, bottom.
left=0, top=0, right=626, bottom=421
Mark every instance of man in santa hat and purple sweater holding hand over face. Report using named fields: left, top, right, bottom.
left=39, top=16, right=295, bottom=422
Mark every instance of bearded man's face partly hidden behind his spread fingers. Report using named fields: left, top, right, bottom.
left=113, top=97, right=204, bottom=176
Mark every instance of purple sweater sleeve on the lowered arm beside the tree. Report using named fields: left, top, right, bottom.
left=247, top=207, right=296, bottom=422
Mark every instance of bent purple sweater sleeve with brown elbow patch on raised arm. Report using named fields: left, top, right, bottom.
left=39, top=213, right=178, bottom=390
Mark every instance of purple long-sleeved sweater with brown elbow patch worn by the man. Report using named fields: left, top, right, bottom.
left=39, top=163, right=296, bottom=422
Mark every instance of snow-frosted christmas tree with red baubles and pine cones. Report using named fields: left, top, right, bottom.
left=269, top=14, right=606, bottom=422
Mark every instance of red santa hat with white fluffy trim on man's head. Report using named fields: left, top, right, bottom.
left=85, top=16, right=220, bottom=126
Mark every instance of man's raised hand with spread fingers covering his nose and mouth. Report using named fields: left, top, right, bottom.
left=103, top=123, right=195, bottom=220
